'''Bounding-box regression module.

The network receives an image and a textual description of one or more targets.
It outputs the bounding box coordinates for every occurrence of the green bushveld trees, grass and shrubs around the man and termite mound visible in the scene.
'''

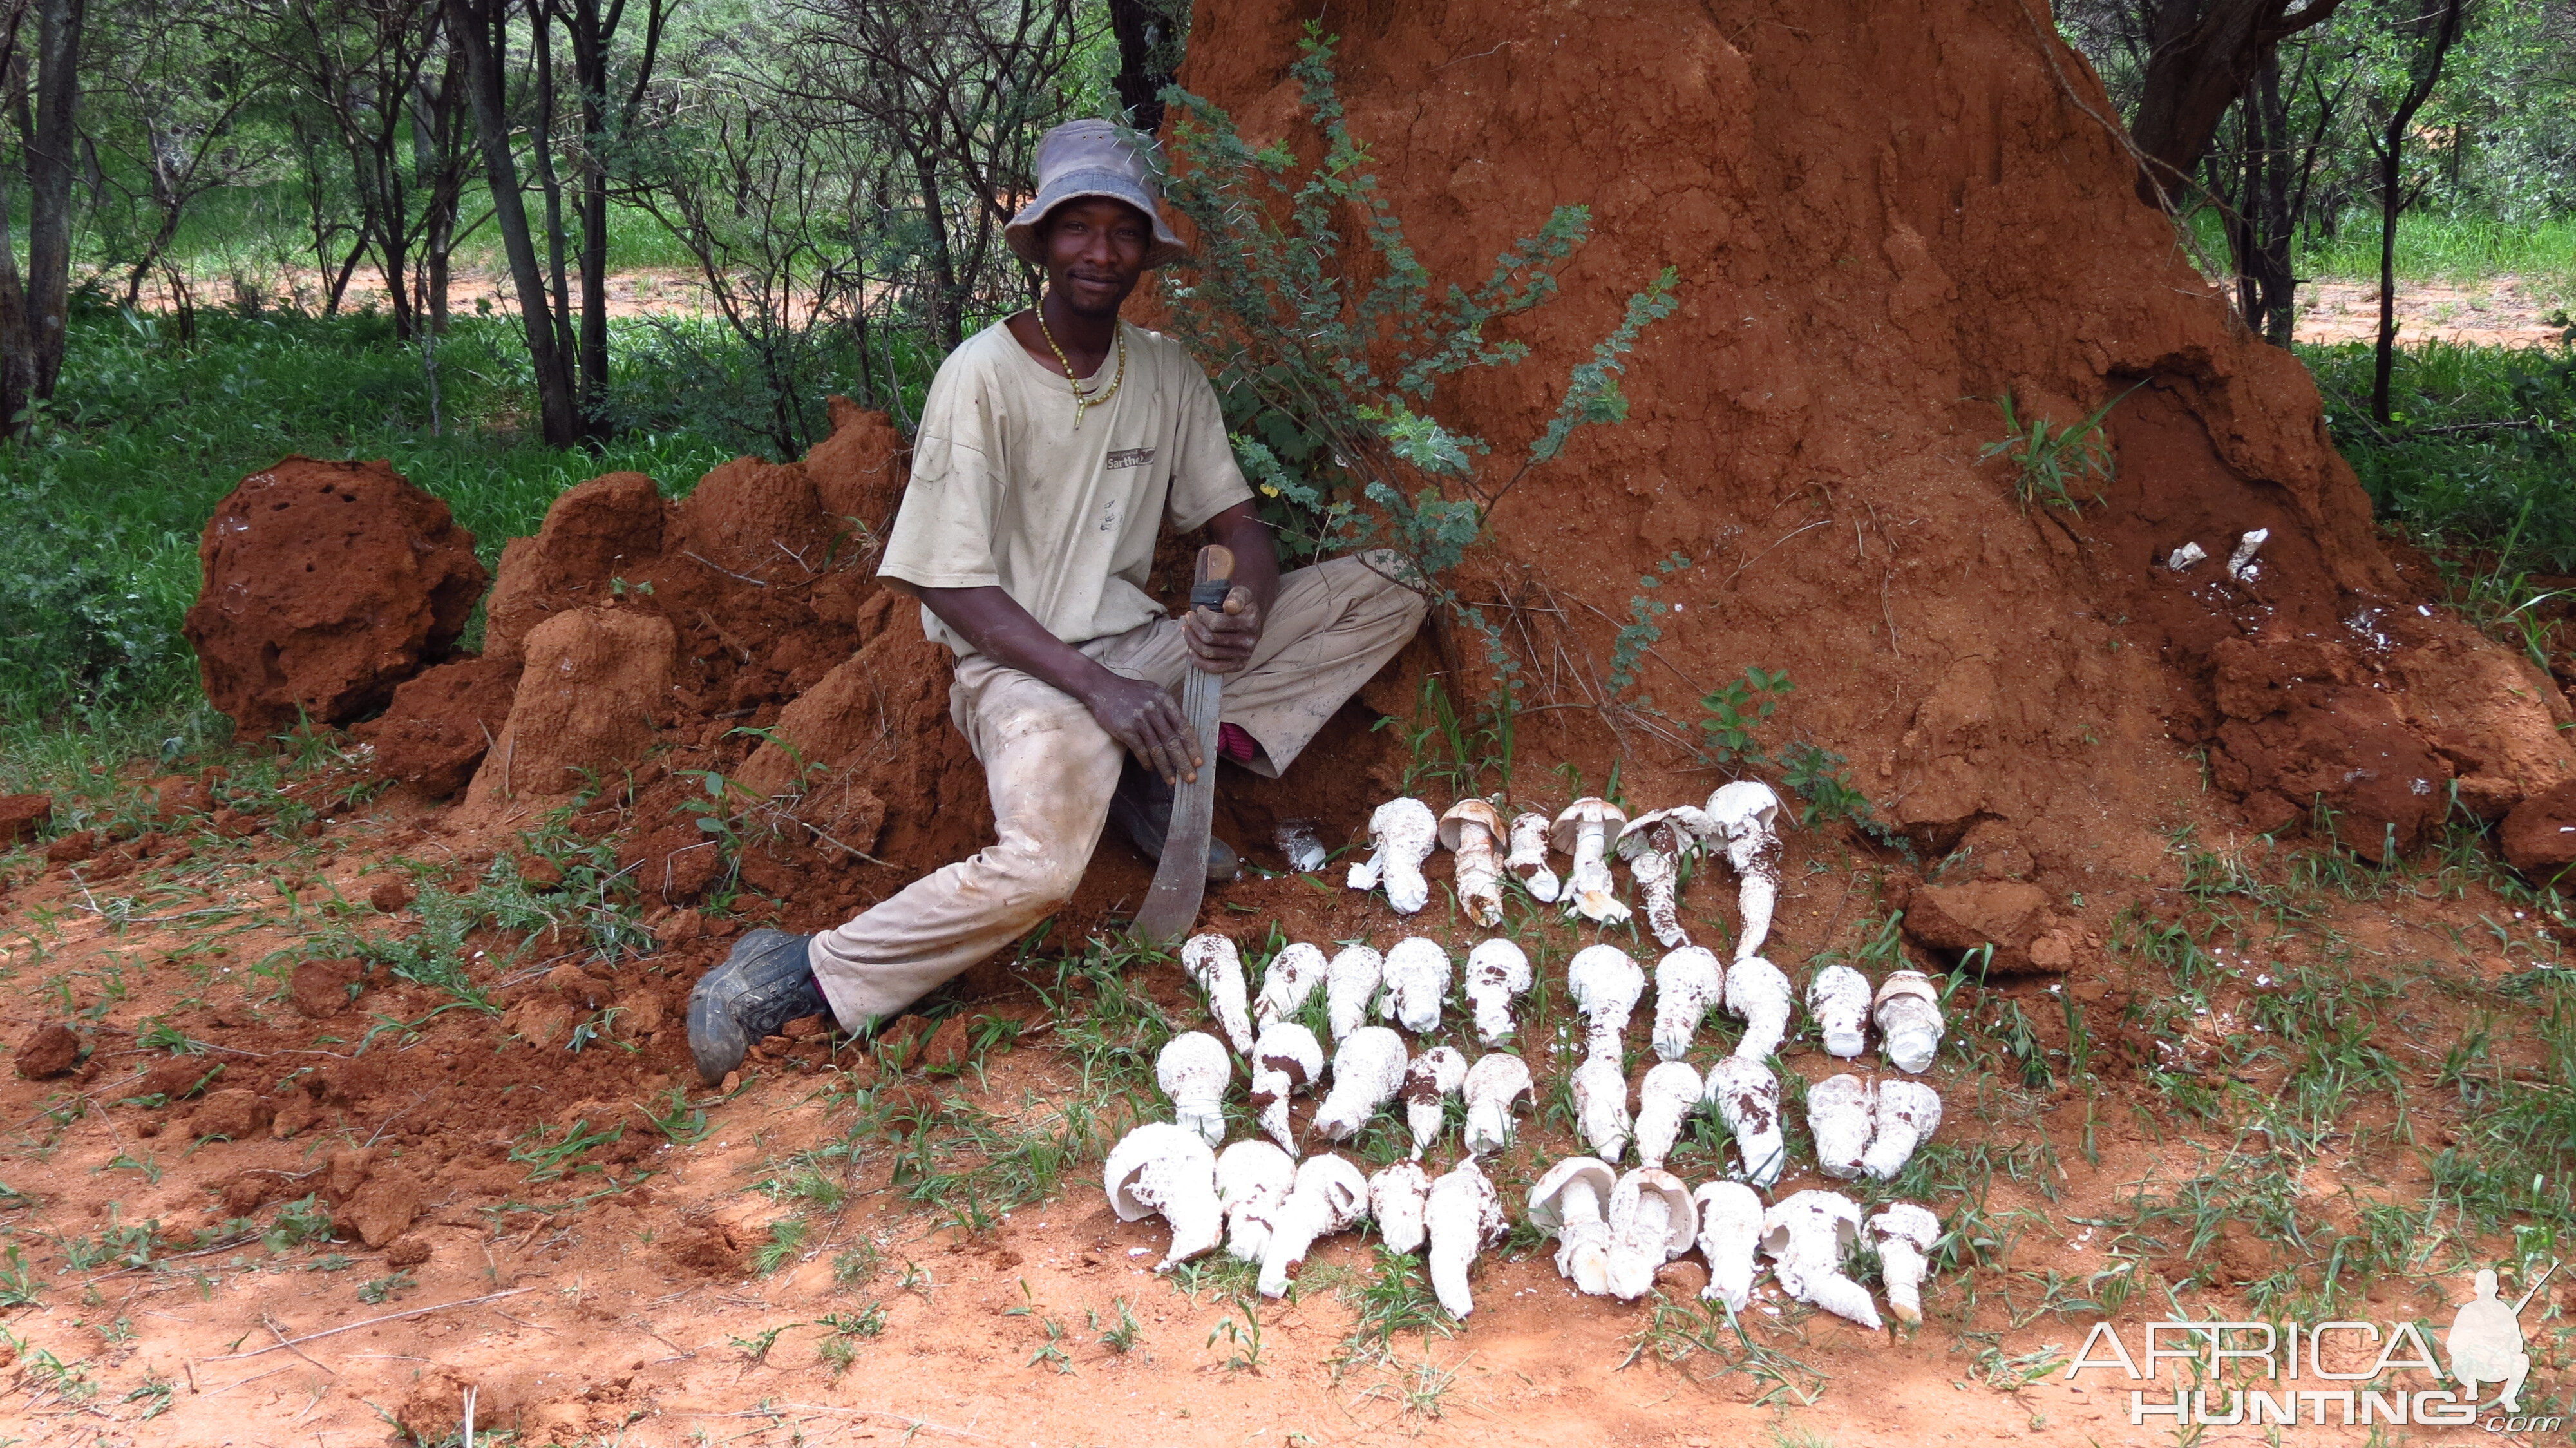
[0,0,2576,776]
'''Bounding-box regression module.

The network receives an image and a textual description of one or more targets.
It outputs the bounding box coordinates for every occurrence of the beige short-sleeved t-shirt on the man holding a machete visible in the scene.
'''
[878,322,1252,657]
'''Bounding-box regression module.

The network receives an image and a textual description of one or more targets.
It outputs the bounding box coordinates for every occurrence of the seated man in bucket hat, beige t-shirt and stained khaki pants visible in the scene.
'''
[688,121,1425,1082]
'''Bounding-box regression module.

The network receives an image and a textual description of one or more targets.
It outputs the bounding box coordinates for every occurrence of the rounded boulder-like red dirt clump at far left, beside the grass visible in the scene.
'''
[185,459,489,734]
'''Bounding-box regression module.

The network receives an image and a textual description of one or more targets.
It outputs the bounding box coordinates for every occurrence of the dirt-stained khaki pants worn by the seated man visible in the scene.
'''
[806,559,1425,1031]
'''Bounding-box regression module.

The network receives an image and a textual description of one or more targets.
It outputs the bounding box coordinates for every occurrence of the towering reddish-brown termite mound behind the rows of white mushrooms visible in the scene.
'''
[1182,0,2571,894]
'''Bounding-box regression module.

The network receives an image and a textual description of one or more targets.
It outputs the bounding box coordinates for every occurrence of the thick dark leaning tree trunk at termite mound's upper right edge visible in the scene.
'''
[2128,0,2342,211]
